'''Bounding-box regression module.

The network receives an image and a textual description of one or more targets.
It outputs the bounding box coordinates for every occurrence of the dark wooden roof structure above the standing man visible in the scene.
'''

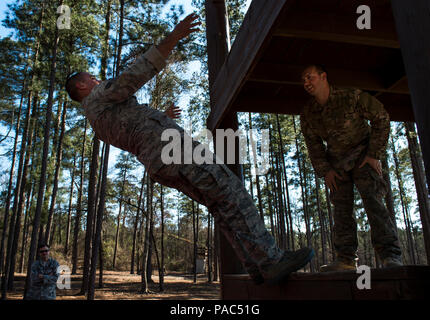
[208,0,414,130]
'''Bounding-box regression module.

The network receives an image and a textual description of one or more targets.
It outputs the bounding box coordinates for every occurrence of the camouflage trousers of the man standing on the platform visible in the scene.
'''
[330,157,401,261]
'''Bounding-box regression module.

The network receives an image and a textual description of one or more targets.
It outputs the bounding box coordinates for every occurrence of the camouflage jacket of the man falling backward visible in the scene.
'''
[82,47,167,172]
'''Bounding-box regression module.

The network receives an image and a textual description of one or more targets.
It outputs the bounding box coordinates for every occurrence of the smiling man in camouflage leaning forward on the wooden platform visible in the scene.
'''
[300,65,402,271]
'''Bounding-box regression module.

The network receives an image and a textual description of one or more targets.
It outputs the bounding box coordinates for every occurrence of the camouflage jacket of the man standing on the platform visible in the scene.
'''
[300,86,390,177]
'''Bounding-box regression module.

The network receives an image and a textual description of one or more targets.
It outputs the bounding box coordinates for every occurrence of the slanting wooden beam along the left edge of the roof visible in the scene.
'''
[207,0,295,130]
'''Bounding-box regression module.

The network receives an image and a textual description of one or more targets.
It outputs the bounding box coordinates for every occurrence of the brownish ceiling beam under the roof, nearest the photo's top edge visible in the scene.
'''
[274,6,400,48]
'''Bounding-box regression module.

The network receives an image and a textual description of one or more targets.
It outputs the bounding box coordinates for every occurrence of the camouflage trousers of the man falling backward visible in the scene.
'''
[144,112,283,278]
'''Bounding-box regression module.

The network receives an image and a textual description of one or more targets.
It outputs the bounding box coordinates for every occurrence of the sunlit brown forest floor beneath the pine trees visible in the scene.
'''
[8,271,221,300]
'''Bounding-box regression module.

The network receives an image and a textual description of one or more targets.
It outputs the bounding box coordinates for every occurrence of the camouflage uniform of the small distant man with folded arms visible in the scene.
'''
[28,258,60,300]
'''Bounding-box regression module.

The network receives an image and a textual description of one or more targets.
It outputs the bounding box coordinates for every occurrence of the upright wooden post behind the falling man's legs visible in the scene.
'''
[205,0,244,290]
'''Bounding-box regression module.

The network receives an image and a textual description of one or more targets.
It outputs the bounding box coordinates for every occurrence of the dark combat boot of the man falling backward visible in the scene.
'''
[261,248,314,285]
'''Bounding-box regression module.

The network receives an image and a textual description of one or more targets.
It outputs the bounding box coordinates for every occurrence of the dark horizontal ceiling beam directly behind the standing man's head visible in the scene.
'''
[248,63,409,94]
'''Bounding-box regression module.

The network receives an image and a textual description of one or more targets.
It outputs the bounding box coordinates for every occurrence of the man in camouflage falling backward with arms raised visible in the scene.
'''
[66,14,313,284]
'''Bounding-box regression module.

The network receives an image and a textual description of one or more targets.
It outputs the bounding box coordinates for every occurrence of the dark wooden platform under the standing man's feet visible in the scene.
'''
[222,266,430,300]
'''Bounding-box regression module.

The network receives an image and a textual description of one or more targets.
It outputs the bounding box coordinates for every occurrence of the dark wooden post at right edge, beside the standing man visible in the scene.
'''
[391,0,430,264]
